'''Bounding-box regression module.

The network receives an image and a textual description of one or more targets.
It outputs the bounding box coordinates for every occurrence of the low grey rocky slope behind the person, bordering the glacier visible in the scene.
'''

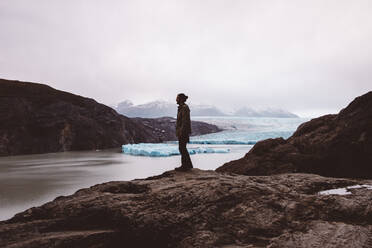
[131,117,222,142]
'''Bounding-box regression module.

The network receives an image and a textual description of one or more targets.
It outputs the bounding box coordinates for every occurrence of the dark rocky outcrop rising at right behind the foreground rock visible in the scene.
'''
[217,92,372,178]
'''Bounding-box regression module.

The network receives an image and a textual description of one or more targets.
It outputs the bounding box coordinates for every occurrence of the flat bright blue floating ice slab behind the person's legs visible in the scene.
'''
[122,143,230,157]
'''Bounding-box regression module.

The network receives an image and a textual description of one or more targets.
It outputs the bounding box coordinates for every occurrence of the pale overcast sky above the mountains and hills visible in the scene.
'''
[0,0,372,116]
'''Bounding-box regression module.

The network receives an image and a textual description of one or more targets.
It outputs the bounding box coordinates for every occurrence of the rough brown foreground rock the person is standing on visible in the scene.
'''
[0,169,372,248]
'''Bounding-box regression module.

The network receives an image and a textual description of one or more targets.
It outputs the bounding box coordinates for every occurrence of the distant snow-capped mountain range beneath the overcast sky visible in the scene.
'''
[114,100,298,118]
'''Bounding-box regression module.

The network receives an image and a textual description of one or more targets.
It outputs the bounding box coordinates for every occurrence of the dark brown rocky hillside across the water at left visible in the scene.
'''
[0,79,221,156]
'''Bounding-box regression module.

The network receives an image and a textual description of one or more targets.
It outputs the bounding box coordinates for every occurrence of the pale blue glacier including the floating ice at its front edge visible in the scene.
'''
[122,116,307,157]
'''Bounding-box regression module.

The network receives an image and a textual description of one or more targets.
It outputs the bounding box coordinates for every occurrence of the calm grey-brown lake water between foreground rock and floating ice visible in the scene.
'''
[0,145,252,220]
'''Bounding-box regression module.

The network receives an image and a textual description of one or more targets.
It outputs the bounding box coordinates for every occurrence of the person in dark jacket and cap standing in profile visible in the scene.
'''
[175,93,193,171]
